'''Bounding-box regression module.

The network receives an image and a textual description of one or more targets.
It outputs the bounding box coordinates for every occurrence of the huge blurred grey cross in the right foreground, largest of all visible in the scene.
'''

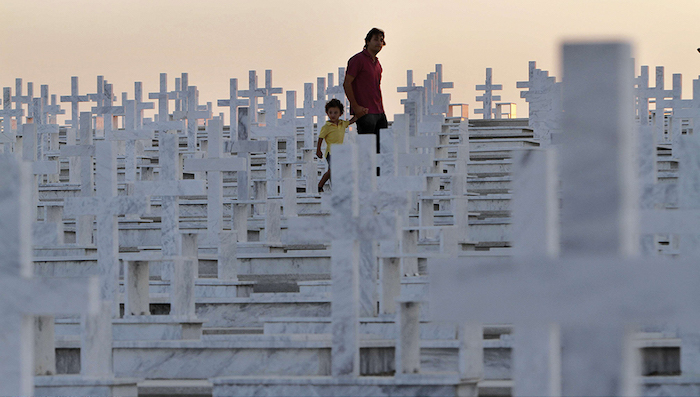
[429,43,700,396]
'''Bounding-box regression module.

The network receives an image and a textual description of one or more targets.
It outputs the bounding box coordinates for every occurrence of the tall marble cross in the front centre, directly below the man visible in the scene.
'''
[288,136,397,377]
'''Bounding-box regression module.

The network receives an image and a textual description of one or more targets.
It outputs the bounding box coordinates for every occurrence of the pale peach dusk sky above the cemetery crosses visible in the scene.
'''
[0,0,700,123]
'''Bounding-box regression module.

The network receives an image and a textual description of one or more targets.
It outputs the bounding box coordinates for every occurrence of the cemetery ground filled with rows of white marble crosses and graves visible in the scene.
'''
[0,43,700,396]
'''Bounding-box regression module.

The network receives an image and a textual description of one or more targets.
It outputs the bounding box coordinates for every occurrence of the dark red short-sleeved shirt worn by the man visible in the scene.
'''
[345,49,384,114]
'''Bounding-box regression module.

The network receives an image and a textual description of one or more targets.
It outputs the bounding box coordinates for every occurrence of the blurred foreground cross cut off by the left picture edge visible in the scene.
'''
[0,155,98,396]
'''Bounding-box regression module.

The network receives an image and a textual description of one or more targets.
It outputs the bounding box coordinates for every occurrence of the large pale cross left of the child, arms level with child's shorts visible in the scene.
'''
[185,117,248,245]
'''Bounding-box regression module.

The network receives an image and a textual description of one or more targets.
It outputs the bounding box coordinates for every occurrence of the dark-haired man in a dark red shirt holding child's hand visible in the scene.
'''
[343,28,388,153]
